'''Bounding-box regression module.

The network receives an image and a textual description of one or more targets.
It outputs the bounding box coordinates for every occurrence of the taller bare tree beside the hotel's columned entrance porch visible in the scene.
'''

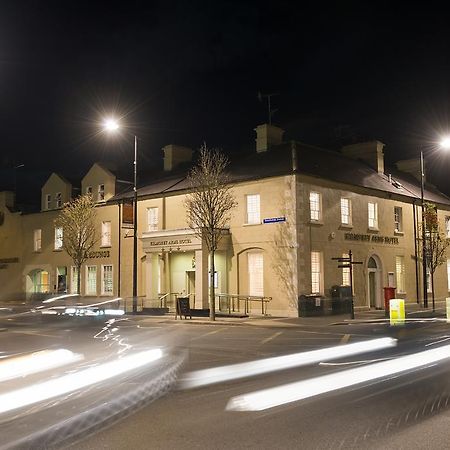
[185,144,236,320]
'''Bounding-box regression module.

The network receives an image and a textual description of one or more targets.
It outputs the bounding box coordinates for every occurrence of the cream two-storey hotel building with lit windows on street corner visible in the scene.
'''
[0,124,450,316]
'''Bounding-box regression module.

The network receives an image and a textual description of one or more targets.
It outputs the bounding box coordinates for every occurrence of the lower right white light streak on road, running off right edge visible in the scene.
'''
[226,345,450,411]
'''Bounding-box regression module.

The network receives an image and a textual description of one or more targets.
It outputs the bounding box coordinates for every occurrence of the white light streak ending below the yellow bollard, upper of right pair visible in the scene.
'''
[181,337,397,389]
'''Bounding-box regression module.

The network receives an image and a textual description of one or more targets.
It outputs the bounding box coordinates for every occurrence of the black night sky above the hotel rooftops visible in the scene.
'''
[0,0,450,202]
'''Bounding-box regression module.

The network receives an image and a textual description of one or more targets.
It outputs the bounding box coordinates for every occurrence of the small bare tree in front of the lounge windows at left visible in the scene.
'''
[55,194,98,293]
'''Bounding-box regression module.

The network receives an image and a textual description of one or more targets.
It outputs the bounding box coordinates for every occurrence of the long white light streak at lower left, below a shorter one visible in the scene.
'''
[0,349,163,413]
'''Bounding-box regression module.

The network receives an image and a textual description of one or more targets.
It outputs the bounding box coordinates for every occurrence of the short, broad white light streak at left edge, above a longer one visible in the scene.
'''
[0,349,83,381]
